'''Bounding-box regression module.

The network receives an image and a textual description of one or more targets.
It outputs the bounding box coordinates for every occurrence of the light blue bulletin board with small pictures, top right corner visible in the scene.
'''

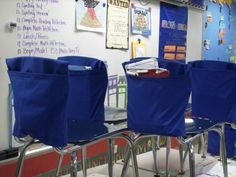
[203,1,236,62]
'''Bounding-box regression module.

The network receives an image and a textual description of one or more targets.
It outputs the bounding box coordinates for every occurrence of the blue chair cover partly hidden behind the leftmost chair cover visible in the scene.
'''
[58,56,108,126]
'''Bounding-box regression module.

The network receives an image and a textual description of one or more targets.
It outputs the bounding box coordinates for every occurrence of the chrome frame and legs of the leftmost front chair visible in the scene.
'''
[16,129,139,177]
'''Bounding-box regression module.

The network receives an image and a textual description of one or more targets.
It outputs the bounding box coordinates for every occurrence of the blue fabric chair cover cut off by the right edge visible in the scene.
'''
[190,60,236,123]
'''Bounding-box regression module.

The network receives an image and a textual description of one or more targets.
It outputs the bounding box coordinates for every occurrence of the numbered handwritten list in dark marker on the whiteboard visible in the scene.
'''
[16,0,79,56]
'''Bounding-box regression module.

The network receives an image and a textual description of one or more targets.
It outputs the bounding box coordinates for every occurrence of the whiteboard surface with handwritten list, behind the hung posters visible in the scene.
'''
[0,0,202,151]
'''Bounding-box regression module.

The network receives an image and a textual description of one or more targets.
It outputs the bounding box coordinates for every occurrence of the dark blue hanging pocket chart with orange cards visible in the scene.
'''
[159,2,188,61]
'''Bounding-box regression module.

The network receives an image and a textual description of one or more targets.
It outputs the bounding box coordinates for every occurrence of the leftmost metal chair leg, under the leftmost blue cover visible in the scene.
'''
[15,140,34,177]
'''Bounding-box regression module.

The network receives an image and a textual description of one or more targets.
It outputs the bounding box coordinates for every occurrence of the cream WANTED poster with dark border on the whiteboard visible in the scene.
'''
[106,0,130,49]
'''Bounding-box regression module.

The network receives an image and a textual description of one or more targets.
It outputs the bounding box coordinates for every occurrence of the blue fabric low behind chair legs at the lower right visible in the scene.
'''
[207,126,236,158]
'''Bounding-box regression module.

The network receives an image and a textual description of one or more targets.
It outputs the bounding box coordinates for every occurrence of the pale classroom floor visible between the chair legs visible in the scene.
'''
[64,148,236,177]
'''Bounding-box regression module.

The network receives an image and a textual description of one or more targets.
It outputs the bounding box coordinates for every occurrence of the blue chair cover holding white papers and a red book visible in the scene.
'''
[123,58,190,136]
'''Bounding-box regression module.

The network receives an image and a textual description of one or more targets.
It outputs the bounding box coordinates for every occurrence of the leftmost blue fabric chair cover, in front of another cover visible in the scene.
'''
[6,57,68,147]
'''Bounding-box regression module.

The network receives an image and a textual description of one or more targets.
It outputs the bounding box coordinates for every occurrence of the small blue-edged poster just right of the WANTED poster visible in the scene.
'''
[131,4,151,36]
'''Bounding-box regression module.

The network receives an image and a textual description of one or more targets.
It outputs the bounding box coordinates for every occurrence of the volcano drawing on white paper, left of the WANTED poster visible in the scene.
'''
[76,0,107,32]
